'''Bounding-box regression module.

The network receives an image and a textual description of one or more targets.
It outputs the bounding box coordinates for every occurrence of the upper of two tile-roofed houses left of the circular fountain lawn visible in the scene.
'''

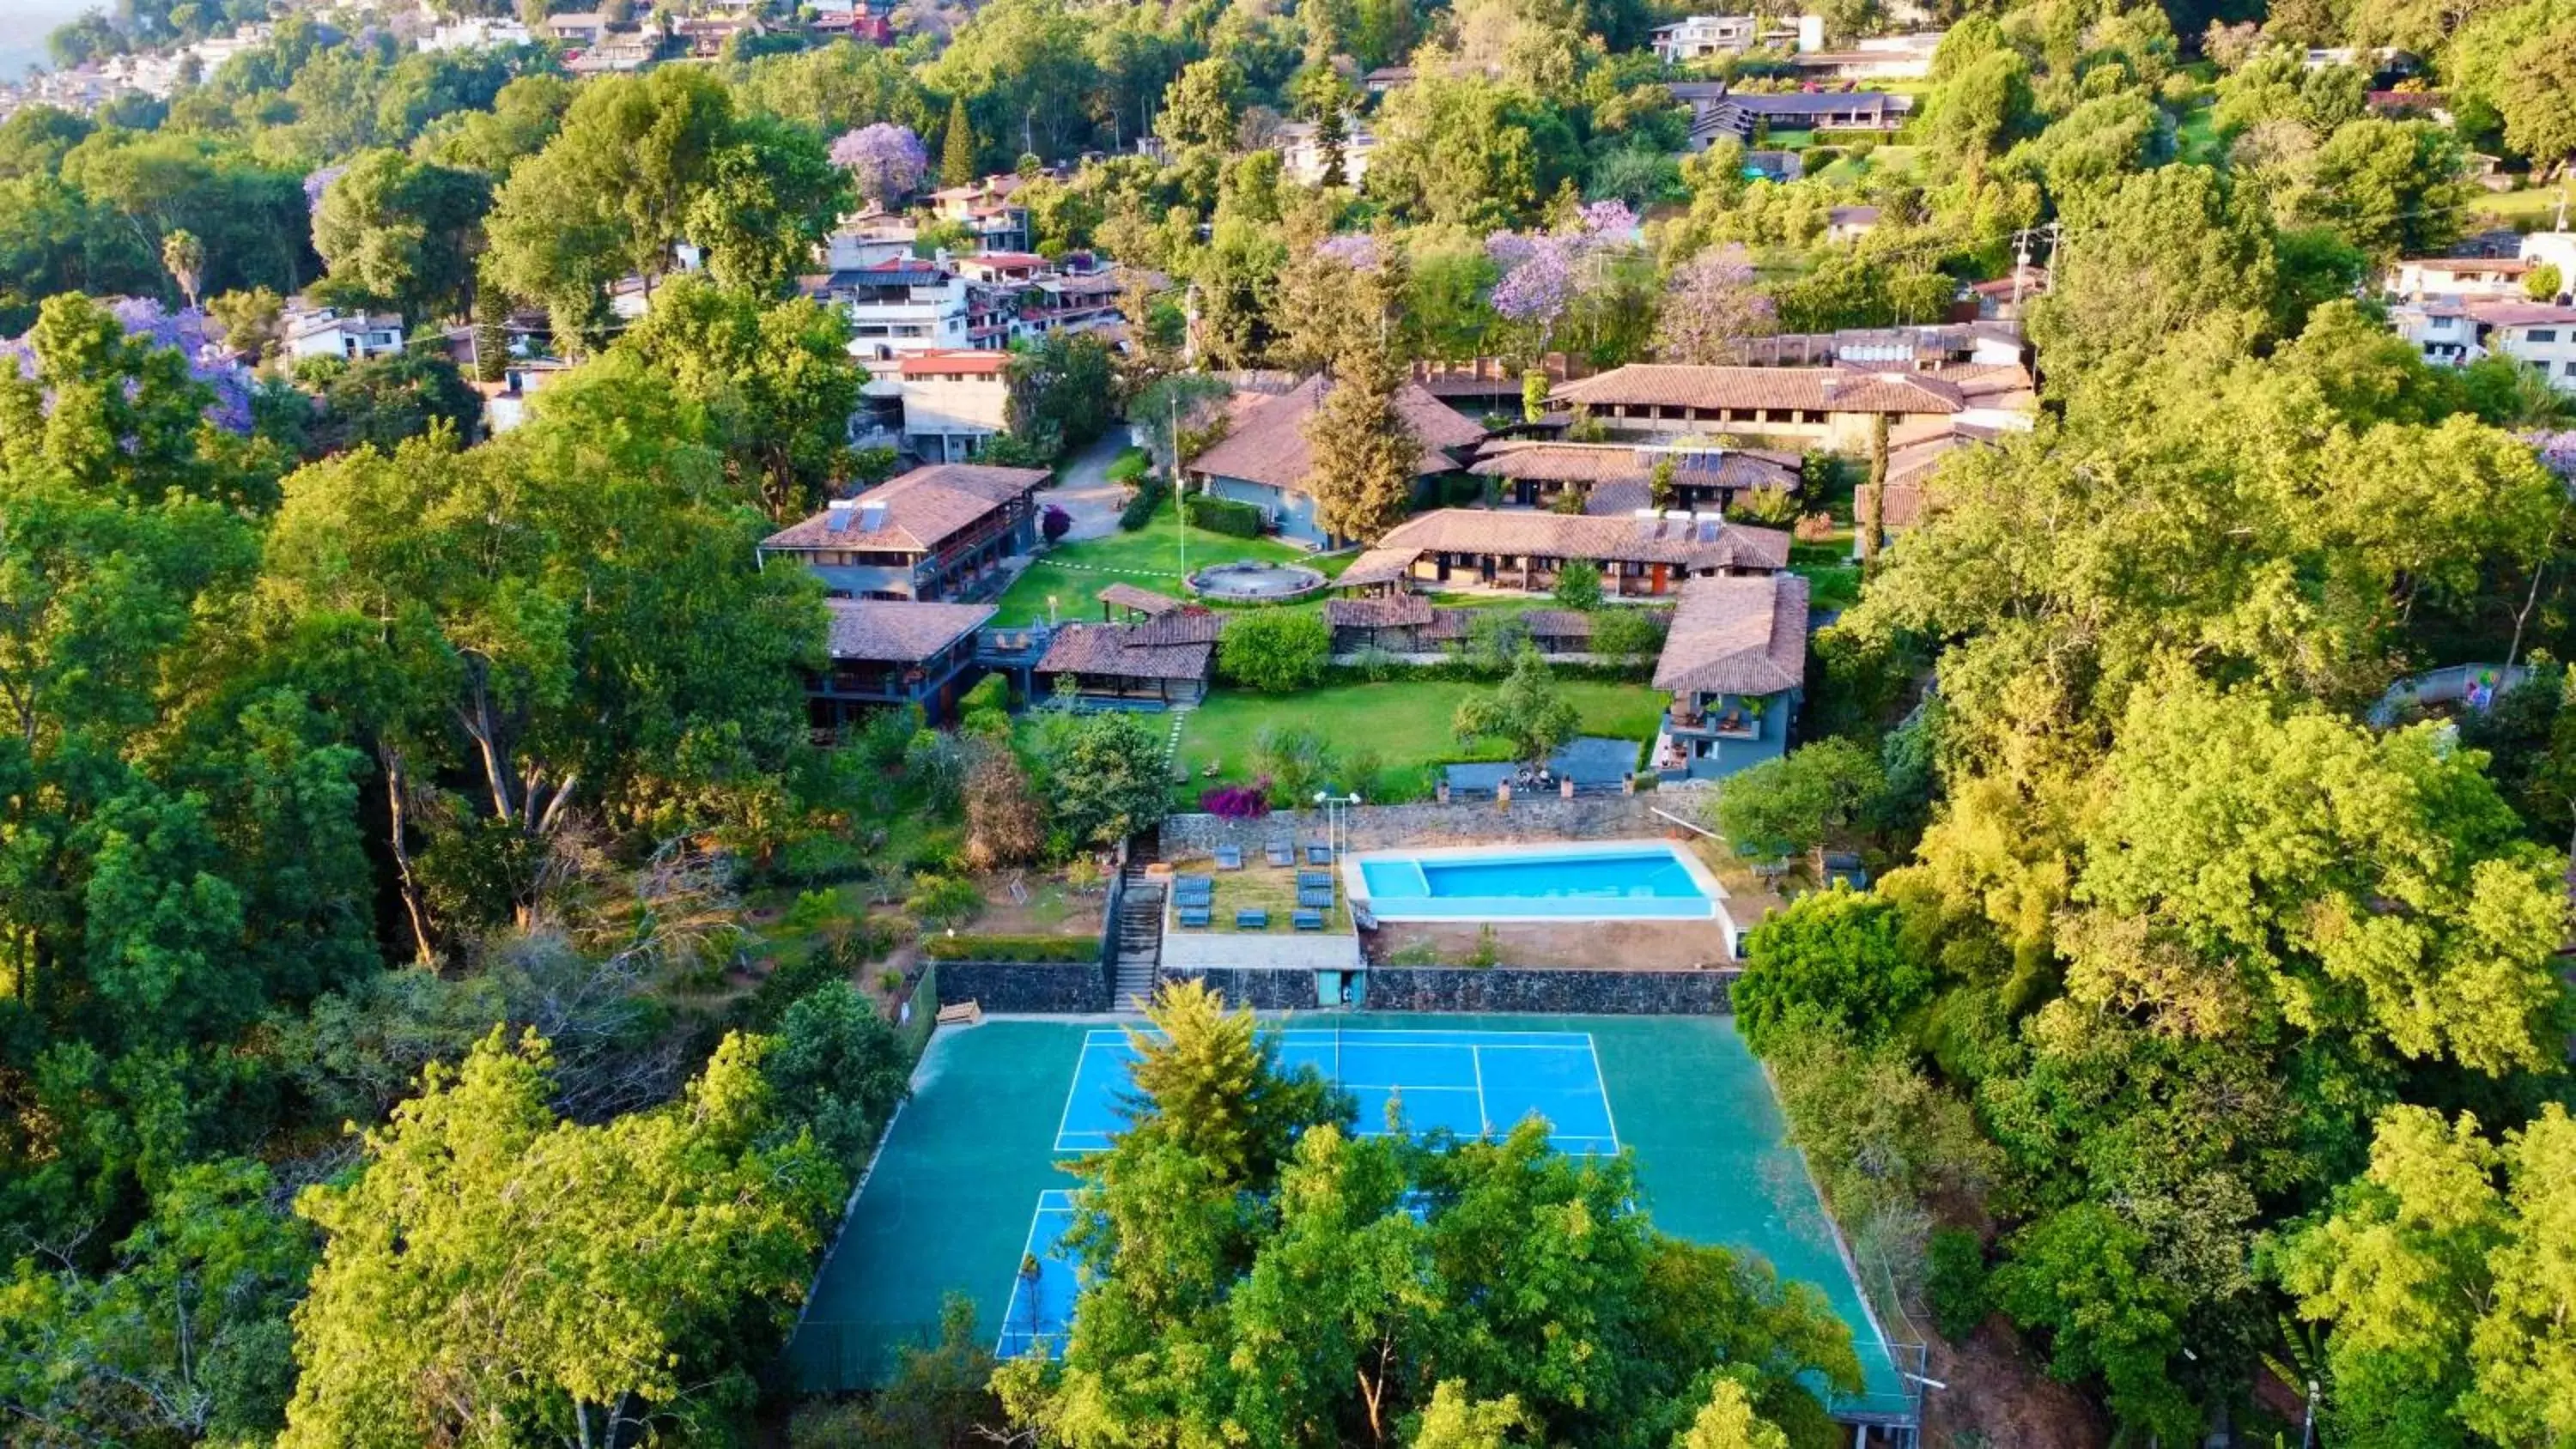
[760,464,1046,600]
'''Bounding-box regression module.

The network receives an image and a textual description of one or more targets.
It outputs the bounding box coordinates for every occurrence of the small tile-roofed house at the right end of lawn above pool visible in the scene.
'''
[1651,574,1806,779]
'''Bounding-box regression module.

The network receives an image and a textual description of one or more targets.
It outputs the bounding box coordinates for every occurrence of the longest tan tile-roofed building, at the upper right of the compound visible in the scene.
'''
[1548,363,2030,453]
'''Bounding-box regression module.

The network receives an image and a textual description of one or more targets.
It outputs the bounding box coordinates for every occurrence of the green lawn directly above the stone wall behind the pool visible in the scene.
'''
[1180,680,1667,800]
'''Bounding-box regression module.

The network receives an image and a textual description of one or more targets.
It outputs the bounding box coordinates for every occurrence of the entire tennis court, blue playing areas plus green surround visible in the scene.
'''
[788,1014,1909,1413]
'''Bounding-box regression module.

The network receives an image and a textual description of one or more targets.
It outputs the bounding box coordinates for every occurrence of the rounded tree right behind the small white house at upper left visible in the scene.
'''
[314,149,492,327]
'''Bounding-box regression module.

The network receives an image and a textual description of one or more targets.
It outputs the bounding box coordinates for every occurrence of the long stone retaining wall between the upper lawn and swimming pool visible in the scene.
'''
[1162,792,1692,859]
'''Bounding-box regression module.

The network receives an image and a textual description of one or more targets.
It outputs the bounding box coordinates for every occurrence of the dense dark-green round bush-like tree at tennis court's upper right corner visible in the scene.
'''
[1734,890,1932,1055]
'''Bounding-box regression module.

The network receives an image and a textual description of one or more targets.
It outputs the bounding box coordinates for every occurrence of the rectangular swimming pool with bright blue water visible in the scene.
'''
[1342,839,1726,921]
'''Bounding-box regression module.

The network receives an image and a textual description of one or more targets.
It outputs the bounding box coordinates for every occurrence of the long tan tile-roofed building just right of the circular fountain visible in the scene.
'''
[1337,507,1790,600]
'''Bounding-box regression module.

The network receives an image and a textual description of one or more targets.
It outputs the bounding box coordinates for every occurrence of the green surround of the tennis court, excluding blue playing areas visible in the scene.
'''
[788,1014,1911,1418]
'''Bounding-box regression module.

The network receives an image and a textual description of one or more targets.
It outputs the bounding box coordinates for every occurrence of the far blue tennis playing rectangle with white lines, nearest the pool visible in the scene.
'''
[1056,1029,1618,1155]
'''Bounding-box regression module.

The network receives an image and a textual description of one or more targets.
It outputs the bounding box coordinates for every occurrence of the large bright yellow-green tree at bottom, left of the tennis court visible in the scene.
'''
[278,1029,845,1446]
